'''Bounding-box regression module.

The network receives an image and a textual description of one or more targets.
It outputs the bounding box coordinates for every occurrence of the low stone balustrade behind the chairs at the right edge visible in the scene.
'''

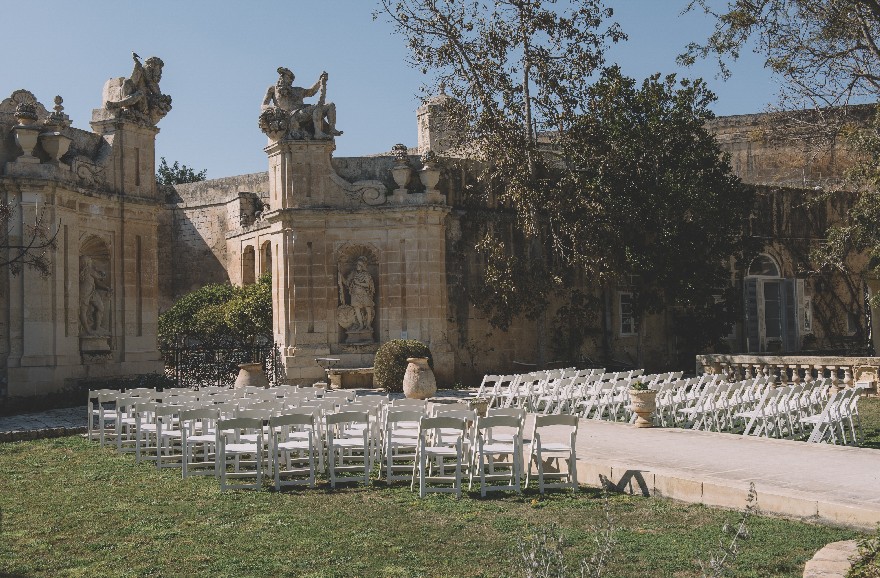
[697,354,880,391]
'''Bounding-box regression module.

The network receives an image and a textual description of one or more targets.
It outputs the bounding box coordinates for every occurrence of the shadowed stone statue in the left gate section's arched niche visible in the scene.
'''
[79,237,111,337]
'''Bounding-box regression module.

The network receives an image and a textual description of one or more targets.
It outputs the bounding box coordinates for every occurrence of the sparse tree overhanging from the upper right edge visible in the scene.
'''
[681,0,880,305]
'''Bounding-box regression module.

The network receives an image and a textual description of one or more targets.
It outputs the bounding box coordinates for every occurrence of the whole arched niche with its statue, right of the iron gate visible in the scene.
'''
[336,245,378,344]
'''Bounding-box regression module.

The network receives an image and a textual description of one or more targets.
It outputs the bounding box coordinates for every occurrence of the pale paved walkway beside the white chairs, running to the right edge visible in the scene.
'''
[0,407,880,530]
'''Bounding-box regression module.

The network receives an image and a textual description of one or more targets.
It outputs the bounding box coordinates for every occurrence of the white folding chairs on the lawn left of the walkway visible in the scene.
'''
[87,394,577,495]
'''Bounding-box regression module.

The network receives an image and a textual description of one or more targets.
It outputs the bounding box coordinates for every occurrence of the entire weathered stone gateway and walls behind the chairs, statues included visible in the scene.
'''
[0,58,878,395]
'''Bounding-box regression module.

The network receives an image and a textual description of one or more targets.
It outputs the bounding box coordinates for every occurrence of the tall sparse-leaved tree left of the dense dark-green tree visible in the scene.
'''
[376,0,625,360]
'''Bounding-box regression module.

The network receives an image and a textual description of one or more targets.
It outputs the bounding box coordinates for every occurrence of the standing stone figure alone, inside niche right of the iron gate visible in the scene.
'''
[337,255,376,343]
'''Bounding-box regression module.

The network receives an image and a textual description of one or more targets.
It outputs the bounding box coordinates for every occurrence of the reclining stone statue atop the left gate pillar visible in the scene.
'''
[104,52,171,126]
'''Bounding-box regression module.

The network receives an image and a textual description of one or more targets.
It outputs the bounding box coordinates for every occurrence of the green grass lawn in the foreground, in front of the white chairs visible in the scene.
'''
[0,436,859,578]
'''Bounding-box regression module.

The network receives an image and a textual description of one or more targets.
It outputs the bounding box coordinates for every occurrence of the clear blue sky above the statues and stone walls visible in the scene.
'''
[0,0,776,178]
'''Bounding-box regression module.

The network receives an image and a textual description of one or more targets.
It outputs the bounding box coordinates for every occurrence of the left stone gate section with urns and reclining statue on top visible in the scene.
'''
[0,58,170,396]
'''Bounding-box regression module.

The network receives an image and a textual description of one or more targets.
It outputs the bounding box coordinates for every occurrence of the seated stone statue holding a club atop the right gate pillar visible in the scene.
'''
[259,66,342,140]
